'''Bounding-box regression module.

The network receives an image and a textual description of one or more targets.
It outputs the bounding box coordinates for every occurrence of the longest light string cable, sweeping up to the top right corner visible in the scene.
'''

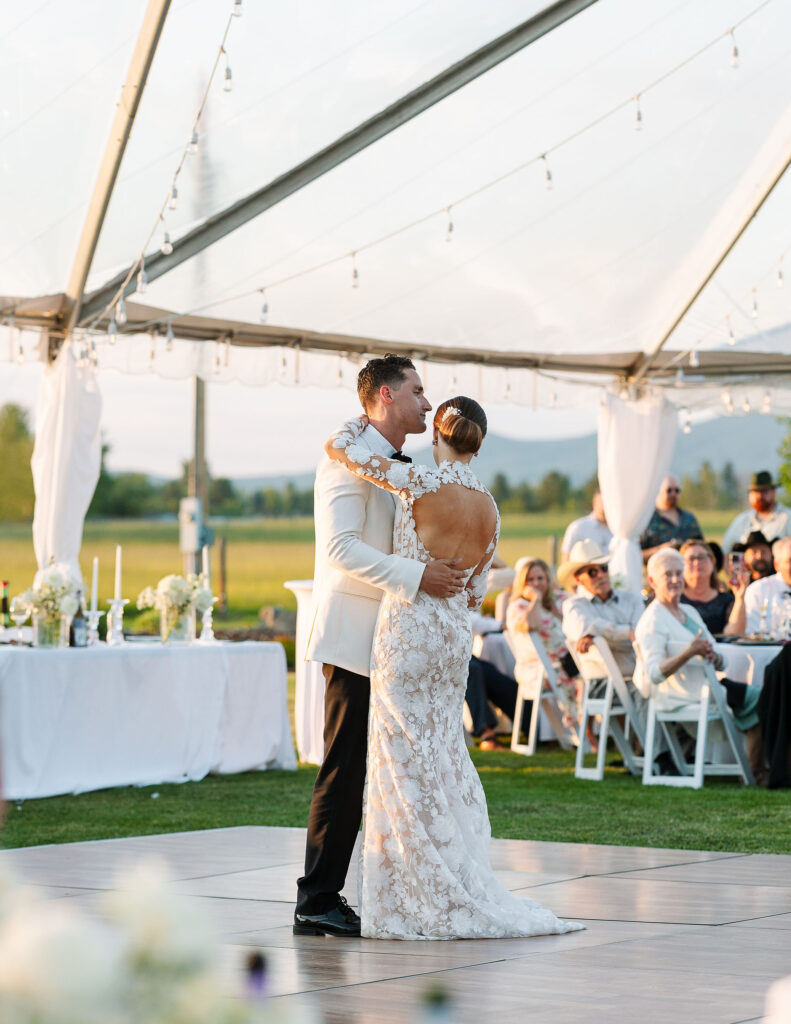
[123,0,773,330]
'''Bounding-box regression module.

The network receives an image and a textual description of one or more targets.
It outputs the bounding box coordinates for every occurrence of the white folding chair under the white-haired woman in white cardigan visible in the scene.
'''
[642,664,755,790]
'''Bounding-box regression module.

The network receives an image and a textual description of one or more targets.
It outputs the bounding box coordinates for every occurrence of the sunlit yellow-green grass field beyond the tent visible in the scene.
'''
[0,512,733,627]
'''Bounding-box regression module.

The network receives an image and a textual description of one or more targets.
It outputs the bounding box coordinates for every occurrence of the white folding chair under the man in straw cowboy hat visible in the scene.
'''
[570,637,646,782]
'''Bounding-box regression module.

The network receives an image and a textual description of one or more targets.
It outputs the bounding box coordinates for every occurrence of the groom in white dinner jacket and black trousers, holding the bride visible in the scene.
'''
[294,354,464,936]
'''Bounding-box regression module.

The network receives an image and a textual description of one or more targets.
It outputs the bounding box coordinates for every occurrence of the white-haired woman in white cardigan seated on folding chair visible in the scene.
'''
[634,548,762,772]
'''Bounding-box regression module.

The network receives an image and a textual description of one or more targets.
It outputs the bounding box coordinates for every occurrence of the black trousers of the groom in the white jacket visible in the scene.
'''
[296,665,371,913]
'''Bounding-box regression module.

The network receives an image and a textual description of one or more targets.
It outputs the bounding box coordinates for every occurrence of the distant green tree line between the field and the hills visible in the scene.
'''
[0,403,778,522]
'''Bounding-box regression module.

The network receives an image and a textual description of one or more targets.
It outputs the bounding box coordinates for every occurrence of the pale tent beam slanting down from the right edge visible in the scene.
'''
[627,106,791,384]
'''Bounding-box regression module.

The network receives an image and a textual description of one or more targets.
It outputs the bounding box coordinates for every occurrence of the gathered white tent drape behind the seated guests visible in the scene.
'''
[598,394,678,591]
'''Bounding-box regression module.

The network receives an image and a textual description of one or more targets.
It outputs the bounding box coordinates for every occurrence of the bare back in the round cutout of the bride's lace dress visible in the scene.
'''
[412,483,497,569]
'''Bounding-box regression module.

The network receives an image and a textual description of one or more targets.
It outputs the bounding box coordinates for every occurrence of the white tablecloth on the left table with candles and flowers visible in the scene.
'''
[0,642,296,800]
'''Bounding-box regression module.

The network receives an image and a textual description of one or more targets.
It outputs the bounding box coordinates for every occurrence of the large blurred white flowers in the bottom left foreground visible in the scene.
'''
[0,861,304,1024]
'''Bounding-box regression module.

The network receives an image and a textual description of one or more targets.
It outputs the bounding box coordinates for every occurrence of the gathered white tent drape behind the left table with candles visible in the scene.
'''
[31,343,101,580]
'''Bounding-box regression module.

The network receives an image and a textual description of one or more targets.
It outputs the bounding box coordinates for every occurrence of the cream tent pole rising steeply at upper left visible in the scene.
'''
[65,0,170,335]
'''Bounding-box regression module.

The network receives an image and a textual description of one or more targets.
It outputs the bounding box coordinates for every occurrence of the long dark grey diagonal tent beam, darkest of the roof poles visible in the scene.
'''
[81,0,597,322]
